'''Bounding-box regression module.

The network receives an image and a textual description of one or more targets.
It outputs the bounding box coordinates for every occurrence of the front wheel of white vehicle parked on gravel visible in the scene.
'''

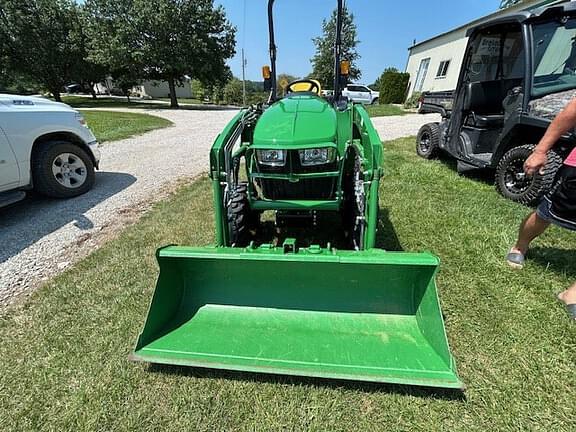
[32,141,95,198]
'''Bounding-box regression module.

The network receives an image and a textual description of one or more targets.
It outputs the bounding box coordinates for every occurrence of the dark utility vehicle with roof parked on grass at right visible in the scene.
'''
[416,2,576,205]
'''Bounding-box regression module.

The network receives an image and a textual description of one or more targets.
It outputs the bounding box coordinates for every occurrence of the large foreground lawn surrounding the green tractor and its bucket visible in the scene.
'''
[0,139,576,432]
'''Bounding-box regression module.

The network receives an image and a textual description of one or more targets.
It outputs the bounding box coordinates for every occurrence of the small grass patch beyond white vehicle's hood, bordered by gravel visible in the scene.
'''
[82,110,172,143]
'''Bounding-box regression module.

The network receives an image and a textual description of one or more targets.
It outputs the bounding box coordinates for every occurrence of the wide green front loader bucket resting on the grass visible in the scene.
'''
[133,246,463,389]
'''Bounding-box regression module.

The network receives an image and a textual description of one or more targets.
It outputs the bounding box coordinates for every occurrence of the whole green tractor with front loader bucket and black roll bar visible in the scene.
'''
[133,0,463,389]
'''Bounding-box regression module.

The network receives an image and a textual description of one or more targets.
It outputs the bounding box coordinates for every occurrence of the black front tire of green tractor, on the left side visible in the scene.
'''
[227,183,260,247]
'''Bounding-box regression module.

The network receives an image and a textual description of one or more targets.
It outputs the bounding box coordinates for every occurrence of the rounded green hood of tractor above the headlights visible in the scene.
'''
[253,95,337,149]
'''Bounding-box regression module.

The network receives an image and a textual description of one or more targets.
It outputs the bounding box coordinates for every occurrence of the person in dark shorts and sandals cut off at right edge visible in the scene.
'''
[506,99,576,320]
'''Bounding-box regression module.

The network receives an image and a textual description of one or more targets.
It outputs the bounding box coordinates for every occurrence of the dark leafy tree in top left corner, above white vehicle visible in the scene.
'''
[0,0,84,101]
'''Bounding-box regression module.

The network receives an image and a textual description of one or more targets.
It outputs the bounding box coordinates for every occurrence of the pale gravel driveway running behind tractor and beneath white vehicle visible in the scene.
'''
[0,109,438,307]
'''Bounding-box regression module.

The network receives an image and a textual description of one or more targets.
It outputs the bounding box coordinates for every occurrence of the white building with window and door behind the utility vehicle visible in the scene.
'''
[406,0,566,96]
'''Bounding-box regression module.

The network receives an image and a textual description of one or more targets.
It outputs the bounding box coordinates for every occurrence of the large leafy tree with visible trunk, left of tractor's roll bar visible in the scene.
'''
[86,0,236,108]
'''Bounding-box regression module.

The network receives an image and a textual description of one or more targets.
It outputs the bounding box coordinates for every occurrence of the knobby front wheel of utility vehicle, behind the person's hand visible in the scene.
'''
[496,144,562,206]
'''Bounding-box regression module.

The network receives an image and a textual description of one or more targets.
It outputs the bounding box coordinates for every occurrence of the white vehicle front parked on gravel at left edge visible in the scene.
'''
[0,94,100,207]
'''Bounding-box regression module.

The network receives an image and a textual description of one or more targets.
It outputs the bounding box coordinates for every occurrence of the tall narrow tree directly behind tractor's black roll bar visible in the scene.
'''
[310,7,362,88]
